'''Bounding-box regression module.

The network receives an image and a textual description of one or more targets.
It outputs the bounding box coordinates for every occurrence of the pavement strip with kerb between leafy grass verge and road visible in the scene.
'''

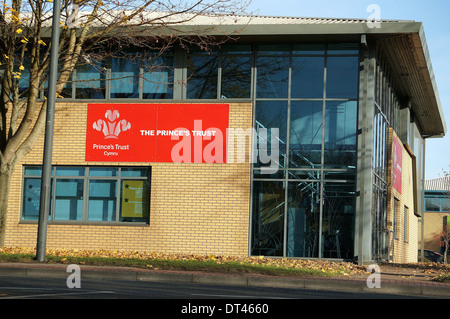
[0,263,450,298]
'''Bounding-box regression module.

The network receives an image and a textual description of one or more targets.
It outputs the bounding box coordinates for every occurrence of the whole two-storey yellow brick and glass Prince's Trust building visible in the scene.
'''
[5,17,446,263]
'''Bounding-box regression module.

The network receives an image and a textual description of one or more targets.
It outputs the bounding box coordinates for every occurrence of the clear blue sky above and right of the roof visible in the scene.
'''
[249,0,450,179]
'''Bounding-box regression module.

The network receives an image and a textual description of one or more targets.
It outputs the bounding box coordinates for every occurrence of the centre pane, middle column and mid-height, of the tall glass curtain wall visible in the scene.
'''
[289,101,323,168]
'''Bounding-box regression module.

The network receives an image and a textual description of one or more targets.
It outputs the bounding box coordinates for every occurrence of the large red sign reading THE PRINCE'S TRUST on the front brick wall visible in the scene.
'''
[86,103,229,163]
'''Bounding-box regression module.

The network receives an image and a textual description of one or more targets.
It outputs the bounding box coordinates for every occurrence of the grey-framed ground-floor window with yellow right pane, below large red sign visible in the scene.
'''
[22,166,150,223]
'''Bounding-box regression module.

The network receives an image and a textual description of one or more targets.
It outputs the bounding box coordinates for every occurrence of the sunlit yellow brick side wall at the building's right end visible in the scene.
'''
[387,128,418,263]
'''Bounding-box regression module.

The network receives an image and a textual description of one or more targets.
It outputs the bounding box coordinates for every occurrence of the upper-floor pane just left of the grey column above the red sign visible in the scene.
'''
[143,57,174,99]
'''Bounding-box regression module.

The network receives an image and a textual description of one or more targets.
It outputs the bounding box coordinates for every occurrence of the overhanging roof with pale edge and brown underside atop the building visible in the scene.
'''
[38,12,447,137]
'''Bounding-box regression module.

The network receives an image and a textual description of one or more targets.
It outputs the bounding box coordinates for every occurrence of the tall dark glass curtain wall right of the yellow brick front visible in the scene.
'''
[250,44,359,259]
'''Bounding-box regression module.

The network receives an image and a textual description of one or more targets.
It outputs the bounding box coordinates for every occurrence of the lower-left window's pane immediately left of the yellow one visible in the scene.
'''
[88,180,117,221]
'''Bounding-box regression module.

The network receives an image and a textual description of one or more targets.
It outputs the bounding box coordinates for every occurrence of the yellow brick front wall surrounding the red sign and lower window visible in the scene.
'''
[5,102,252,255]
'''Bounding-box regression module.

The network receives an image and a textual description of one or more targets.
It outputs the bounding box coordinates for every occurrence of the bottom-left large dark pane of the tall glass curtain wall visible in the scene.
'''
[251,181,285,256]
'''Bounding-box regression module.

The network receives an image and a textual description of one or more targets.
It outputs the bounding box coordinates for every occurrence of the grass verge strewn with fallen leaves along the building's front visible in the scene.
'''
[0,252,360,277]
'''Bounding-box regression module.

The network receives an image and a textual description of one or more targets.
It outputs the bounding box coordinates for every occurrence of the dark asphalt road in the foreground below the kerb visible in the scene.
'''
[0,276,428,301]
